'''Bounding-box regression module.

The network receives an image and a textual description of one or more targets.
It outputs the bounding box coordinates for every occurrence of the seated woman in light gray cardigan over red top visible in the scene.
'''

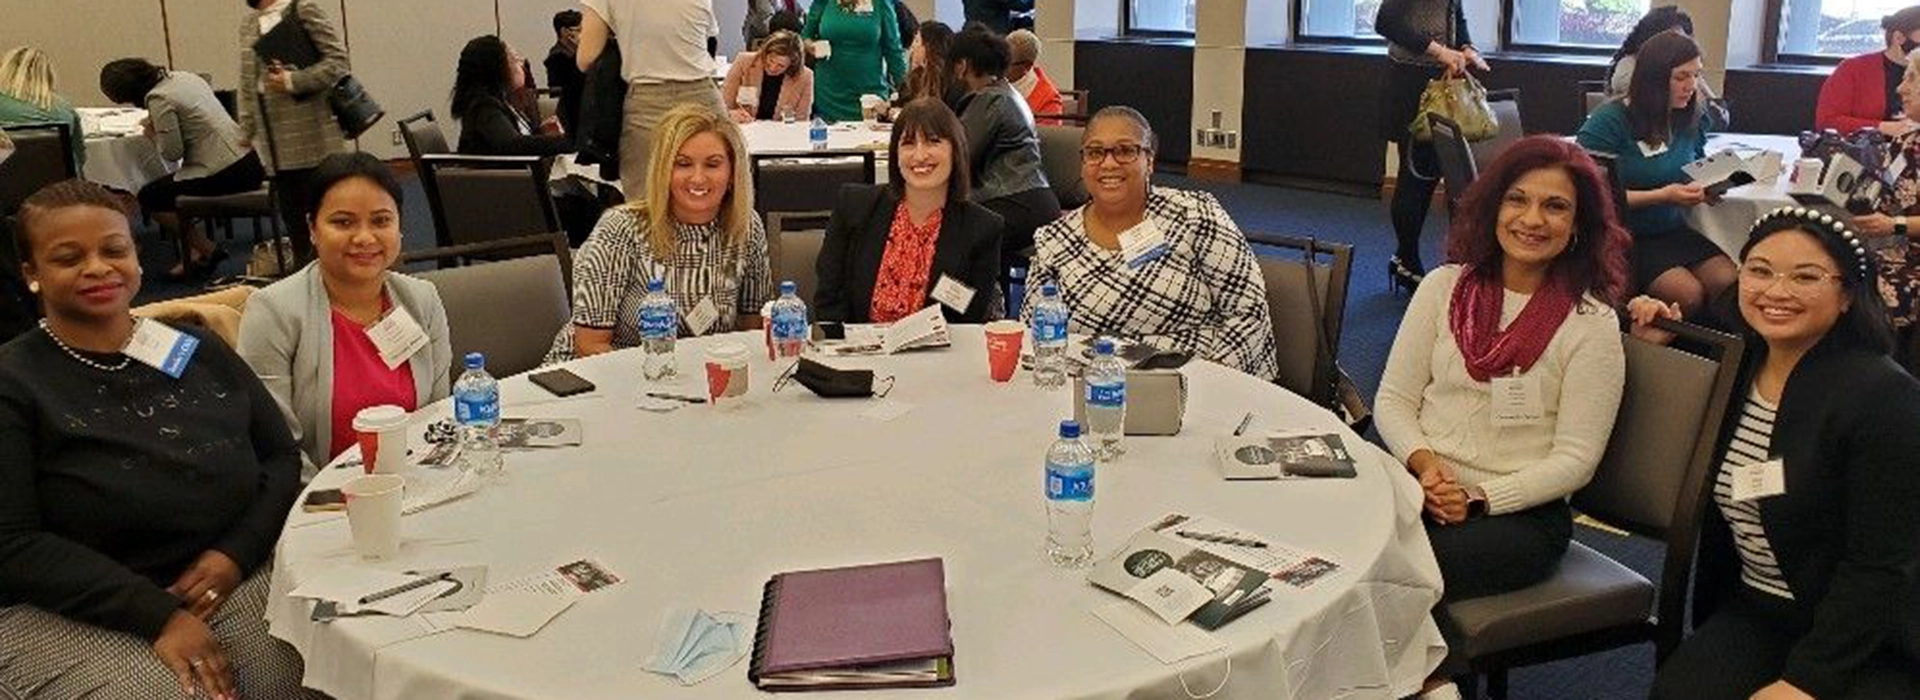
[240,153,453,478]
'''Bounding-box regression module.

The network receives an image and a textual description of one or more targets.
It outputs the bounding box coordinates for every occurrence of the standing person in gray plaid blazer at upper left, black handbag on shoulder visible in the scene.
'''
[238,0,349,265]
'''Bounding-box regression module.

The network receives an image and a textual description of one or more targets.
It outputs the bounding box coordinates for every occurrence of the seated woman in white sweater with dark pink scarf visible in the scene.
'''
[1377,136,1628,698]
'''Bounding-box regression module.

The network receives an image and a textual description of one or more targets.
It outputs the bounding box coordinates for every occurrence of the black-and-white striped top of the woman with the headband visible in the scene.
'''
[1713,391,1793,600]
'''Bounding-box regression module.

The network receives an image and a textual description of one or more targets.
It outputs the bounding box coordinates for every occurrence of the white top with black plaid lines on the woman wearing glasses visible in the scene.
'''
[1021,188,1279,380]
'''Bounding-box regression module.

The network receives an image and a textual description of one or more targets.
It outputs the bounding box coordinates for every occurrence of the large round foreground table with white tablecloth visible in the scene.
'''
[267,326,1444,700]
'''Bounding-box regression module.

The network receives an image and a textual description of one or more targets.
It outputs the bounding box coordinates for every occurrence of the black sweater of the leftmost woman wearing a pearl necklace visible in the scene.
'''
[0,328,300,639]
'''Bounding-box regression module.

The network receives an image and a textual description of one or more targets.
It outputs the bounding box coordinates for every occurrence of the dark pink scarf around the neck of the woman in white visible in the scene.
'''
[1448,267,1574,382]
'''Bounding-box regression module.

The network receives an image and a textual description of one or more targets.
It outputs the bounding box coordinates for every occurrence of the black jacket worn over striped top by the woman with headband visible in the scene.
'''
[1695,337,1920,698]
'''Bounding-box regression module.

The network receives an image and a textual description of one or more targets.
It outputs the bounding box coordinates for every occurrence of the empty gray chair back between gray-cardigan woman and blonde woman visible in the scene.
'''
[396,232,572,376]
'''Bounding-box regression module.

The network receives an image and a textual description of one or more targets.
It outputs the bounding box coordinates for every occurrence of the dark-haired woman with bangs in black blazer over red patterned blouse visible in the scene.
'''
[814,98,1002,324]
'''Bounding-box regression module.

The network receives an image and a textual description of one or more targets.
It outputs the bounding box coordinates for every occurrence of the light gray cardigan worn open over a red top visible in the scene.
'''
[240,263,453,478]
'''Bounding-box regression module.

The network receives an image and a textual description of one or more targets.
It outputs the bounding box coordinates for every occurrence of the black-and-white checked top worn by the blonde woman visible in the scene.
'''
[547,207,774,364]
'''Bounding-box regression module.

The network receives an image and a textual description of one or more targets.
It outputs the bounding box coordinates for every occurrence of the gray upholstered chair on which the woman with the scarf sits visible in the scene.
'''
[1448,320,1743,700]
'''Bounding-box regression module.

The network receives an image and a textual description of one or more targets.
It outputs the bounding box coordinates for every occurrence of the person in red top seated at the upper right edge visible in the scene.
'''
[1812,6,1920,136]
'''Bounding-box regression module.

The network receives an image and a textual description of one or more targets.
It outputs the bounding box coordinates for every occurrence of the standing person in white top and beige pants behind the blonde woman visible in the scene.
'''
[574,0,726,199]
